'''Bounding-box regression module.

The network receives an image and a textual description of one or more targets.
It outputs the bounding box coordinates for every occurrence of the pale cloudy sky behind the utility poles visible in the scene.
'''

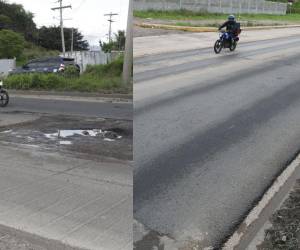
[7,0,129,45]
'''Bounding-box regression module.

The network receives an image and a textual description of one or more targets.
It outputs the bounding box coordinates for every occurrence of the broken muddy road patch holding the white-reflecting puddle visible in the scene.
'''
[0,113,132,160]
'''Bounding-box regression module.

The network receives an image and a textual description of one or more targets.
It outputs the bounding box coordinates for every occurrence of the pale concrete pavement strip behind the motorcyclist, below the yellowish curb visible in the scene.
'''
[133,28,300,57]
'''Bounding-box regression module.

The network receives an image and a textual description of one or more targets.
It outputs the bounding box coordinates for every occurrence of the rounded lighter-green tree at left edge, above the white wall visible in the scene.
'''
[0,30,25,59]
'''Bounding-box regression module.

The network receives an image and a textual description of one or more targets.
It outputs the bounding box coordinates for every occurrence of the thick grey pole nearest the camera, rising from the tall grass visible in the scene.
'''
[123,0,133,84]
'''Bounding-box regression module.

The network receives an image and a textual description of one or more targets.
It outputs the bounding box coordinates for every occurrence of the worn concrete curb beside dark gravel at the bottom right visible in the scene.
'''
[222,154,300,250]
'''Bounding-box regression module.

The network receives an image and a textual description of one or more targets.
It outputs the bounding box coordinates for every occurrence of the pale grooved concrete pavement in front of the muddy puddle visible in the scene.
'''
[0,145,132,250]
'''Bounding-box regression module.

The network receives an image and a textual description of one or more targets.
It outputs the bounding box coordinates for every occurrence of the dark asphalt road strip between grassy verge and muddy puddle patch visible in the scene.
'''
[3,97,132,120]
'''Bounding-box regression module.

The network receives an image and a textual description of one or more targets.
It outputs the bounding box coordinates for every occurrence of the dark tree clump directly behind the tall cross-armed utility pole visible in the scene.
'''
[38,26,89,51]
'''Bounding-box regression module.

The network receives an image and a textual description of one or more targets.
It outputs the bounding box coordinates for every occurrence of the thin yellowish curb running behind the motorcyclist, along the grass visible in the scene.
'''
[135,23,300,32]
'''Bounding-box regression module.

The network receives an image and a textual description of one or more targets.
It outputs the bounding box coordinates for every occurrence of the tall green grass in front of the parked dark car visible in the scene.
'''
[4,58,132,94]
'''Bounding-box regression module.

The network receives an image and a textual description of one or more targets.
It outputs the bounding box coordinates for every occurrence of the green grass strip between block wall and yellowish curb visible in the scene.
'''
[134,9,300,23]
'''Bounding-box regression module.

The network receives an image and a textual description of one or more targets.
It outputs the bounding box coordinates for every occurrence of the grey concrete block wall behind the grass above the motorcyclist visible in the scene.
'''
[133,0,287,15]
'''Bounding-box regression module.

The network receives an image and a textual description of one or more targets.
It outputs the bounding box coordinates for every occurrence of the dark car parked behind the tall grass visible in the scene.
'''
[10,56,80,75]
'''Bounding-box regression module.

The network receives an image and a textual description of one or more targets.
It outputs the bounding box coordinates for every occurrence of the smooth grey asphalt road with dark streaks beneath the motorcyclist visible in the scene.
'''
[134,32,300,247]
